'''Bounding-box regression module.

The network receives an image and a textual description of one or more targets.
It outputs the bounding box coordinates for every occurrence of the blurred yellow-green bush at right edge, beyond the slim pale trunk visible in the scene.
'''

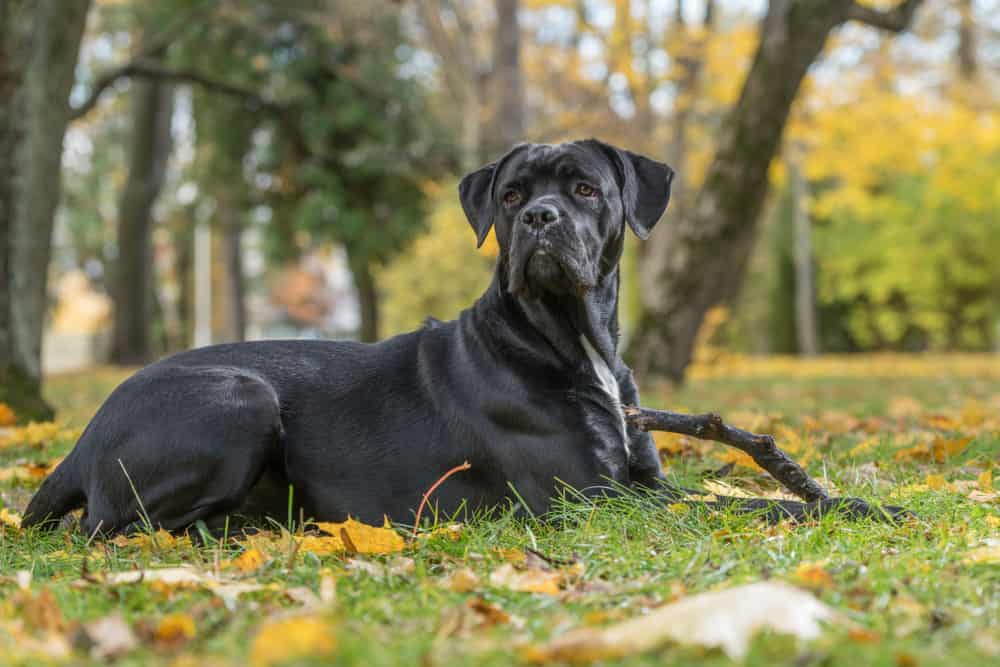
[814,98,1000,350]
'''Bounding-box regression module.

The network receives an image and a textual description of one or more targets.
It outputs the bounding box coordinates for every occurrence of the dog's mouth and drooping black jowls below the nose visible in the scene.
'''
[507,239,596,298]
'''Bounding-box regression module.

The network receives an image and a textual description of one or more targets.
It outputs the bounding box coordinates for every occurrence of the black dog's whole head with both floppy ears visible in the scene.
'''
[459,139,673,298]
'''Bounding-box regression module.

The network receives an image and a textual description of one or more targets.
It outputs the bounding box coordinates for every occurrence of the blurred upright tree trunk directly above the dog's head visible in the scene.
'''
[492,0,524,155]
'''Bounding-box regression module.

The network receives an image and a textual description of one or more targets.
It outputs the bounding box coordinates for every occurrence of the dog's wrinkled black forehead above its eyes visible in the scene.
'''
[497,143,616,189]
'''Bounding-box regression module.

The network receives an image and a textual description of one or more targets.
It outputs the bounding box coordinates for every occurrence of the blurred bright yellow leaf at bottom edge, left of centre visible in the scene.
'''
[250,616,337,667]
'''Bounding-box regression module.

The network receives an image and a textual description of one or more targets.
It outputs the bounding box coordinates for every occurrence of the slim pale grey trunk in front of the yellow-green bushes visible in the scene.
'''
[787,147,819,357]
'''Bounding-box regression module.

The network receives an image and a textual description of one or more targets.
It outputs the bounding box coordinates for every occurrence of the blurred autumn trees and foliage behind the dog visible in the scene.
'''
[0,0,1000,419]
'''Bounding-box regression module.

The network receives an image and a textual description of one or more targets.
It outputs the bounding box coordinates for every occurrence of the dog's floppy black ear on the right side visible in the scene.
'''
[590,139,674,241]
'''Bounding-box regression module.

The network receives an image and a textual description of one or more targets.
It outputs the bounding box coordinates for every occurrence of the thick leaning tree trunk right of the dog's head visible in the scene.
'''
[628,0,919,382]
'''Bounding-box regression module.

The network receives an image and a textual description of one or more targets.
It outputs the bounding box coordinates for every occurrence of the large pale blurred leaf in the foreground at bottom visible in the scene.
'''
[525,581,838,663]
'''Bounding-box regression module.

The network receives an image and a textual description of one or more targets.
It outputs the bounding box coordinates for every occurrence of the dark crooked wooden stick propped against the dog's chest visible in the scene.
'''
[624,406,829,503]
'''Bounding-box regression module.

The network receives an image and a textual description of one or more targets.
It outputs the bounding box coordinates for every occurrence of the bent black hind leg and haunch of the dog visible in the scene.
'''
[77,367,283,534]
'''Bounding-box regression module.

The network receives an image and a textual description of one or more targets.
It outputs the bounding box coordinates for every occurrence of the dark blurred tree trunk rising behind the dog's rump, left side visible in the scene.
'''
[111,49,174,365]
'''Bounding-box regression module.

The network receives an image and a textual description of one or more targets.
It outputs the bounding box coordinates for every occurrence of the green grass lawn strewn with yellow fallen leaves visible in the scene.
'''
[0,356,1000,667]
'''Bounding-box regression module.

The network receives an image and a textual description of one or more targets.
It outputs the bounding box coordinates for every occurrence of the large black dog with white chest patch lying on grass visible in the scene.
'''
[24,140,900,534]
